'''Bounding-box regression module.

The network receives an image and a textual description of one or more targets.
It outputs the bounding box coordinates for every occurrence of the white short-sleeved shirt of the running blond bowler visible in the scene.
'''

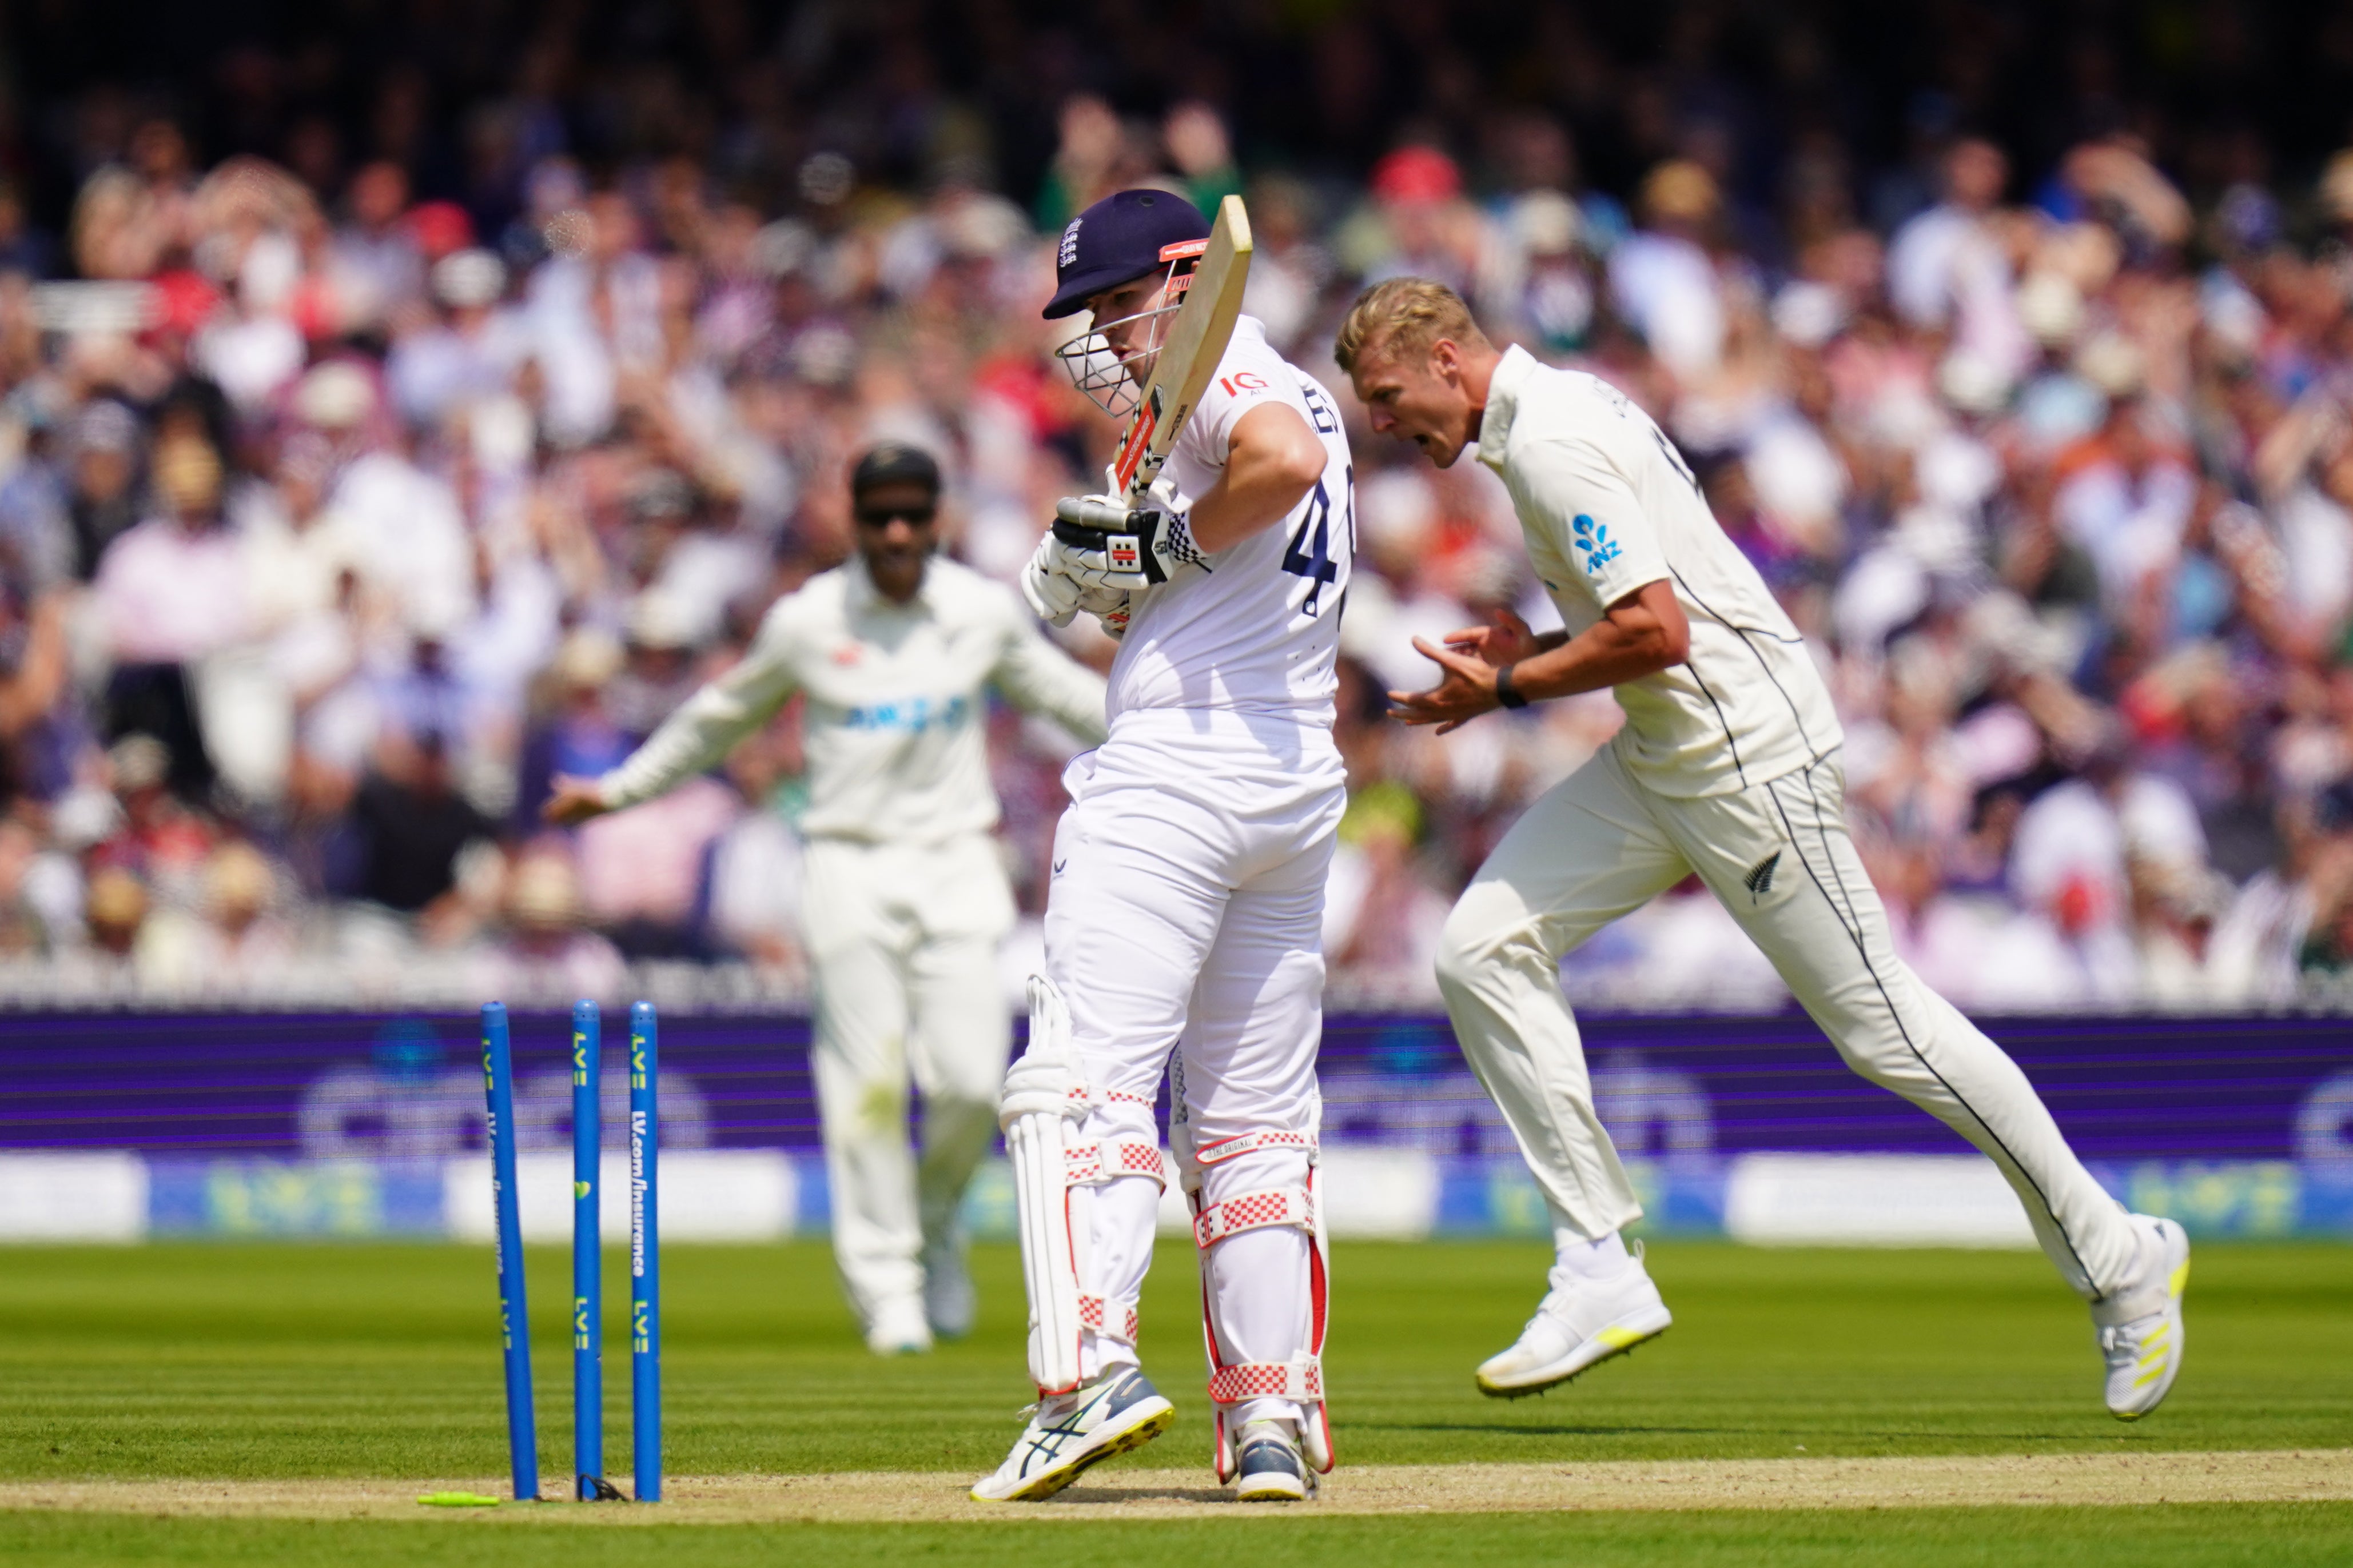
[1478,348,1842,795]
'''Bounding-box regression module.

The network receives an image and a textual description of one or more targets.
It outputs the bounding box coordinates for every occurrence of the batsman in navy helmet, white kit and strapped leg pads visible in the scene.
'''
[972,190,1353,1502]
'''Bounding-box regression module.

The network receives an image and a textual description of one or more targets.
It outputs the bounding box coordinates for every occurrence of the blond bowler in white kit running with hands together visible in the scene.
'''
[1336,277,2188,1420]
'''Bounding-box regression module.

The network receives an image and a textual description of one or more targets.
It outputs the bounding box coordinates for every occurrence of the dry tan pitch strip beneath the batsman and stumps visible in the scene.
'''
[0,1448,2353,1523]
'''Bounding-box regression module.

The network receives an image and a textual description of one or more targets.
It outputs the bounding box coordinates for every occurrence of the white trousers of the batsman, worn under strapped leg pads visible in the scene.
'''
[1045,710,1348,1429]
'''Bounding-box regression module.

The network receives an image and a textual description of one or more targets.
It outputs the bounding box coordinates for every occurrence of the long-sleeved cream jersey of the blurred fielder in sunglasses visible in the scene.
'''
[588,557,1106,841]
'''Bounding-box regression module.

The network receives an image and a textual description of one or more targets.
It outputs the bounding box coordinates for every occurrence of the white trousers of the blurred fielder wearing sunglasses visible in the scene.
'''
[802,832,1014,1326]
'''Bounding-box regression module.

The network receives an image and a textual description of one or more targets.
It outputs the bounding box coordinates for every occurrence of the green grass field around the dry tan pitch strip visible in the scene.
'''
[0,1241,2353,1563]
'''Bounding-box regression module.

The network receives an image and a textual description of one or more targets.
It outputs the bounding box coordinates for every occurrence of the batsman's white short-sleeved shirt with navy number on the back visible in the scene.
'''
[1110,315,1355,727]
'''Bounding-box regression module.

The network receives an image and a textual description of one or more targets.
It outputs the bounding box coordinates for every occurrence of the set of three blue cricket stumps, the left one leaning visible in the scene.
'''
[483,1002,661,1502]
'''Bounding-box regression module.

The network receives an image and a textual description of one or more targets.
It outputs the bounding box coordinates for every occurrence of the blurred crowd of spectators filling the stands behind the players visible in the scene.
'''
[0,7,2353,1008]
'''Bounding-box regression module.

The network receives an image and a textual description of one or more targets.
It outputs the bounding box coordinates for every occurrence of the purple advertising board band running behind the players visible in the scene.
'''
[0,1011,2353,1162]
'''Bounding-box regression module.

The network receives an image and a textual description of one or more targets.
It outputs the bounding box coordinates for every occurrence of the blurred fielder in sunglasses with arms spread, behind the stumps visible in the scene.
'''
[546,442,1104,1356]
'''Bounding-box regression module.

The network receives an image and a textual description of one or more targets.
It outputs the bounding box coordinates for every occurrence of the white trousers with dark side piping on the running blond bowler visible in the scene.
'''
[1438,748,2136,1300]
